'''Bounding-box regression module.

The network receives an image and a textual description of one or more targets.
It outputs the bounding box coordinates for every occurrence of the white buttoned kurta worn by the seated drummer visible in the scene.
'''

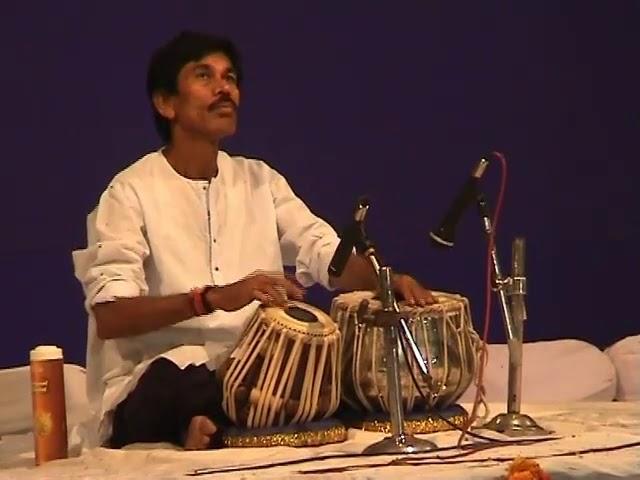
[73,151,339,445]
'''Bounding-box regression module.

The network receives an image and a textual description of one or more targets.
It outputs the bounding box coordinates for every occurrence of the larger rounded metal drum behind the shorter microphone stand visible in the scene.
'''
[331,292,481,413]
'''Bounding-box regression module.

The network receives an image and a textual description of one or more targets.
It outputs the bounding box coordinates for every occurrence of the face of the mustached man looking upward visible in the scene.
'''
[161,53,240,141]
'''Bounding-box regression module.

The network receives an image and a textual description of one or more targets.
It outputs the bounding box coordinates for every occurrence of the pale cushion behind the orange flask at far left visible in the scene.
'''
[0,364,89,435]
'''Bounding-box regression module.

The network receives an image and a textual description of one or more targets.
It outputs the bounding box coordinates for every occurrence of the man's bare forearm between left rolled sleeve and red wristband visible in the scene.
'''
[93,293,195,340]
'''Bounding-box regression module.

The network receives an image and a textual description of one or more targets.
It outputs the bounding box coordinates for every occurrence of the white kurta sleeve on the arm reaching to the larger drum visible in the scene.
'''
[271,170,340,289]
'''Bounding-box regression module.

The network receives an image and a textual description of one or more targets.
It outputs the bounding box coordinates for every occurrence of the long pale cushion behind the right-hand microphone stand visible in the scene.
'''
[460,340,616,405]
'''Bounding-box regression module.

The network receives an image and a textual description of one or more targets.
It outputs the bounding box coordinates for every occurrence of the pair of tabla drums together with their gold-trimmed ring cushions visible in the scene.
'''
[220,292,480,446]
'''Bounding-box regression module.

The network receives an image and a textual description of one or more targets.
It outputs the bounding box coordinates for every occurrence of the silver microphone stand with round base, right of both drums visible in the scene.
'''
[477,193,551,437]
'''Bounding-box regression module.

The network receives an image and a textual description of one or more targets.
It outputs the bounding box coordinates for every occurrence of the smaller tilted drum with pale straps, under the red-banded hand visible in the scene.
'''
[220,302,340,429]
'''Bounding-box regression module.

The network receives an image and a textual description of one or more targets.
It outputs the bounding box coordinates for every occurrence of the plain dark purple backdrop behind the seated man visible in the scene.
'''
[0,0,640,367]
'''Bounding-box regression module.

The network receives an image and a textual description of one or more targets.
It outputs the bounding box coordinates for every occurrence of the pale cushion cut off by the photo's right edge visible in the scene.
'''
[605,335,640,401]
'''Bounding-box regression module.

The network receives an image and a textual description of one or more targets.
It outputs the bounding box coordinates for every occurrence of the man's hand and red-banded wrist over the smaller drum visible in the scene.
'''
[206,271,304,312]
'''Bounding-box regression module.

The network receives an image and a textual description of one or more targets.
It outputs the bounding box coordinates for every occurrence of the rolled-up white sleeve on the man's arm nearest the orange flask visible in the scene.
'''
[73,181,149,306]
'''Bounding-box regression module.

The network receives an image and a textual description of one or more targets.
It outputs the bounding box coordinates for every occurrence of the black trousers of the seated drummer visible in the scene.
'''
[109,358,230,448]
